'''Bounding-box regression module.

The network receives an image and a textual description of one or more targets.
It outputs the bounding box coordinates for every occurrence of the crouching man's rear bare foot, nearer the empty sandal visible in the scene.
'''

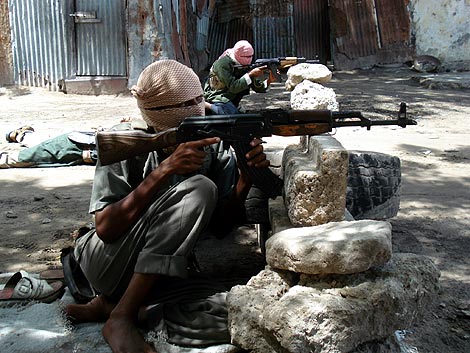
[65,295,116,324]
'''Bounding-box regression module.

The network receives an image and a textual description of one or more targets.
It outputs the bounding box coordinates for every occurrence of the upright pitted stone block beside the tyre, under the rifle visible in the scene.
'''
[282,135,349,226]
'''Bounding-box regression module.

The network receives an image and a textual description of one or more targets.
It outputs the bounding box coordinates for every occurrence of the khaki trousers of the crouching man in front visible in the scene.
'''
[75,175,217,298]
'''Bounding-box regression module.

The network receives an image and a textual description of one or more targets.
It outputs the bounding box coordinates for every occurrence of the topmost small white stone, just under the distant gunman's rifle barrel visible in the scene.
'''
[286,63,333,91]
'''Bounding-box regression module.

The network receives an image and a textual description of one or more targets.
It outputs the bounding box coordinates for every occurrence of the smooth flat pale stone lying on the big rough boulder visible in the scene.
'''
[266,220,392,274]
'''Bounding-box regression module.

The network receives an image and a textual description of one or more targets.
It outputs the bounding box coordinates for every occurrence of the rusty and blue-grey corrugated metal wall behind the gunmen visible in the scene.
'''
[8,0,412,89]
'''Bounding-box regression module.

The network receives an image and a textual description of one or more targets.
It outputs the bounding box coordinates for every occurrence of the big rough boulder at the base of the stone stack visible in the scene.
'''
[227,253,439,353]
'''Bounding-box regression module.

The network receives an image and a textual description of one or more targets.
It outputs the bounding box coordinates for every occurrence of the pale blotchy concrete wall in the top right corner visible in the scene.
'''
[409,0,470,70]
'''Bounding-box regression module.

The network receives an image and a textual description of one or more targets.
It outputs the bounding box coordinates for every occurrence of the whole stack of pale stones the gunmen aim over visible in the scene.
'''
[227,64,440,353]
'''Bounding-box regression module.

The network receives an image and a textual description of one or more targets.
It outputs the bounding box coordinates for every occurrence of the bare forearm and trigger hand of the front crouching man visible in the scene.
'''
[95,137,220,243]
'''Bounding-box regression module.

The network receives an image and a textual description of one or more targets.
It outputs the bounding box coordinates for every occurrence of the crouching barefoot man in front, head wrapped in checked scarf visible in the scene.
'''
[65,60,269,352]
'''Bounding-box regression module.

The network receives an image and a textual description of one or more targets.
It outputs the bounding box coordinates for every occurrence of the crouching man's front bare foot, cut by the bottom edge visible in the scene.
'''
[102,315,157,353]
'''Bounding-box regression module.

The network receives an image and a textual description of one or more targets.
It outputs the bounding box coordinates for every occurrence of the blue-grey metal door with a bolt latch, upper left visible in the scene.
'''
[70,0,127,77]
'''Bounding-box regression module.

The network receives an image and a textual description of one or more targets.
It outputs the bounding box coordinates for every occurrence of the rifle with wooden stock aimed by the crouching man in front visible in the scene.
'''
[96,103,416,198]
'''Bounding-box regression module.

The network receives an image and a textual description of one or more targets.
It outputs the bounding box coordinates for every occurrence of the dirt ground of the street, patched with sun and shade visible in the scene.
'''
[0,68,470,353]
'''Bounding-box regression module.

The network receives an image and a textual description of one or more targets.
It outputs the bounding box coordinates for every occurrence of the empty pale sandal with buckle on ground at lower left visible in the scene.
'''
[0,271,64,305]
